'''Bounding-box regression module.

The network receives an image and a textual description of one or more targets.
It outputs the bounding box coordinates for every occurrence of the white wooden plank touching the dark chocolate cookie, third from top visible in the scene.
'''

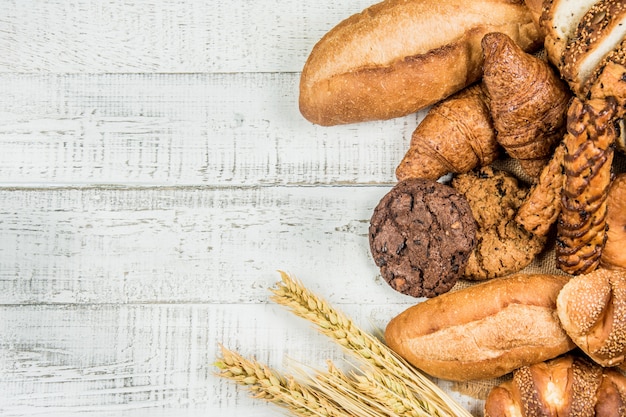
[0,186,420,304]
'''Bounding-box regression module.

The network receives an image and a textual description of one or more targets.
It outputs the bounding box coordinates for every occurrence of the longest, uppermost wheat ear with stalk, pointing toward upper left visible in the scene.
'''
[271,271,471,417]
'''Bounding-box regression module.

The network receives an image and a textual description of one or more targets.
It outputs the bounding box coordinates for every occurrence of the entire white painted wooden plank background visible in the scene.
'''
[0,0,478,417]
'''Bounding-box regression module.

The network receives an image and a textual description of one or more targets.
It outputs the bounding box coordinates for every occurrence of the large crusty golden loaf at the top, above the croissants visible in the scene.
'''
[299,0,543,125]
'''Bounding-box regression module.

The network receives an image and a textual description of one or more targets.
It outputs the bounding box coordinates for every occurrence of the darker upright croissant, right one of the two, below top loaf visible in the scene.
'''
[482,33,571,178]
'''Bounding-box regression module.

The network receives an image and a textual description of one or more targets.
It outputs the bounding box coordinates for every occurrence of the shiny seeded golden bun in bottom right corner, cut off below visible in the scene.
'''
[484,354,626,417]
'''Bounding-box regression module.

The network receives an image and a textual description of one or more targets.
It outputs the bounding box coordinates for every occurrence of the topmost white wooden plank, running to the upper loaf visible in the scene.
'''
[0,0,371,73]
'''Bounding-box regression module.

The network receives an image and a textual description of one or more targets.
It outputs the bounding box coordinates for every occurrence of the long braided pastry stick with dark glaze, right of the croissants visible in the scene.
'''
[556,97,617,275]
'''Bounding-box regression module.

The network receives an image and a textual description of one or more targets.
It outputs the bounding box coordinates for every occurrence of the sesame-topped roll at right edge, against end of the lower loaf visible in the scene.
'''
[557,268,626,366]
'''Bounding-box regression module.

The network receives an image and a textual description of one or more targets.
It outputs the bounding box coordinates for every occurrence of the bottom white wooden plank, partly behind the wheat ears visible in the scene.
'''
[0,303,464,417]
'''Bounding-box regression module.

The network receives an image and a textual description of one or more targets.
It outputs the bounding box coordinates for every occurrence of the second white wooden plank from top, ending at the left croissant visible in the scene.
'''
[0,74,423,187]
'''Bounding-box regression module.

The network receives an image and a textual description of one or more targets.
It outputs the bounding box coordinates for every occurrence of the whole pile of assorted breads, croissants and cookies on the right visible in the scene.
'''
[299,0,626,417]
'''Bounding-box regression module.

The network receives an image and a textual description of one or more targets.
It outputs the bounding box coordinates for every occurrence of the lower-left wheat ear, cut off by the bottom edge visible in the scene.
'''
[215,346,353,417]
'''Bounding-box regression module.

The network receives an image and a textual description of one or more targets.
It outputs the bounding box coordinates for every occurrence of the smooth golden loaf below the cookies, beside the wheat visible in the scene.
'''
[385,274,575,381]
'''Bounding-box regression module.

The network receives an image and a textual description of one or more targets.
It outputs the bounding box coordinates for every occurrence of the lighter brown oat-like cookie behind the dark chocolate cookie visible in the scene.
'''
[451,167,546,281]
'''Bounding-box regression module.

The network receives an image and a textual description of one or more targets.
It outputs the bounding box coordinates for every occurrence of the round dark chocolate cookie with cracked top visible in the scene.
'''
[369,178,476,297]
